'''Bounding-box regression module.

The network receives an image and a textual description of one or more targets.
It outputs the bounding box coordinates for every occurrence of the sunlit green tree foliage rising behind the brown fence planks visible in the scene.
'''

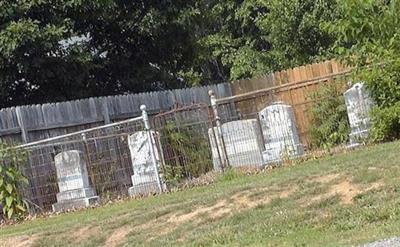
[198,0,336,80]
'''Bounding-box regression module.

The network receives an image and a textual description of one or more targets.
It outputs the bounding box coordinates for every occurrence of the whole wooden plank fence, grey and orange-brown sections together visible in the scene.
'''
[0,60,349,147]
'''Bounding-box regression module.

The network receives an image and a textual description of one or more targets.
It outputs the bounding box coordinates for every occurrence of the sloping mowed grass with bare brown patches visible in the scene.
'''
[0,142,400,246]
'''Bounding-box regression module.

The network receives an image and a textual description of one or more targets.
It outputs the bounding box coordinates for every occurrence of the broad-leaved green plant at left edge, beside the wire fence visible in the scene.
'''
[0,142,28,219]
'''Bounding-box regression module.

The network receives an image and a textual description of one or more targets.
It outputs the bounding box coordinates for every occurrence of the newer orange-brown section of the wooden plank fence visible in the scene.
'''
[219,60,350,145]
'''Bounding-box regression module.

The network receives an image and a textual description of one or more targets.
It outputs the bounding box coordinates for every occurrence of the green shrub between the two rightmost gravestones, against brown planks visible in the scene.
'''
[310,83,350,148]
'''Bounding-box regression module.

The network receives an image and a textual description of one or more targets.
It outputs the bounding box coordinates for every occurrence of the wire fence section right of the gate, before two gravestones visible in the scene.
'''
[210,72,349,168]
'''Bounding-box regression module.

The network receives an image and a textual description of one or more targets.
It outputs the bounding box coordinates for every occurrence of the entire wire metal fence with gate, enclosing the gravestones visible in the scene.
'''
[1,70,358,211]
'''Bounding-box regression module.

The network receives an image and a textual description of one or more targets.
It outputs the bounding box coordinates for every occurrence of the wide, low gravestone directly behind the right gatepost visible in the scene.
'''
[208,119,264,170]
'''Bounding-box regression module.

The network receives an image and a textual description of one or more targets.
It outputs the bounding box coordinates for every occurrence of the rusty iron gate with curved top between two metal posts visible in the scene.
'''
[153,104,222,185]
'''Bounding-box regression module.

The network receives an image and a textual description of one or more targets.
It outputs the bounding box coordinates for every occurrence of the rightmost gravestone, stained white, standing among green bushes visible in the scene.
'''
[344,83,374,146]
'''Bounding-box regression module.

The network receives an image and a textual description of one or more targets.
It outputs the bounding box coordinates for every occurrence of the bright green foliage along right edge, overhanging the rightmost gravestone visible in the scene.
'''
[327,0,400,141]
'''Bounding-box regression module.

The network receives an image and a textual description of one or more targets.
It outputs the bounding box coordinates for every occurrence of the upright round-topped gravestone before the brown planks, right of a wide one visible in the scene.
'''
[258,102,304,163]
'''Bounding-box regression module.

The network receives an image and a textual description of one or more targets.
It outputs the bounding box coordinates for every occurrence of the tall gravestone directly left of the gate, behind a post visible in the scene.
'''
[128,131,165,196]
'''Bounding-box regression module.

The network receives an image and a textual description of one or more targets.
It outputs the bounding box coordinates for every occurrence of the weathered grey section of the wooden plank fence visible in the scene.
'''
[0,83,232,143]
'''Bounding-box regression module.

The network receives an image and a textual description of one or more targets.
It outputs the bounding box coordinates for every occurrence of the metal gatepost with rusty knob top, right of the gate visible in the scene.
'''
[208,90,229,171]
